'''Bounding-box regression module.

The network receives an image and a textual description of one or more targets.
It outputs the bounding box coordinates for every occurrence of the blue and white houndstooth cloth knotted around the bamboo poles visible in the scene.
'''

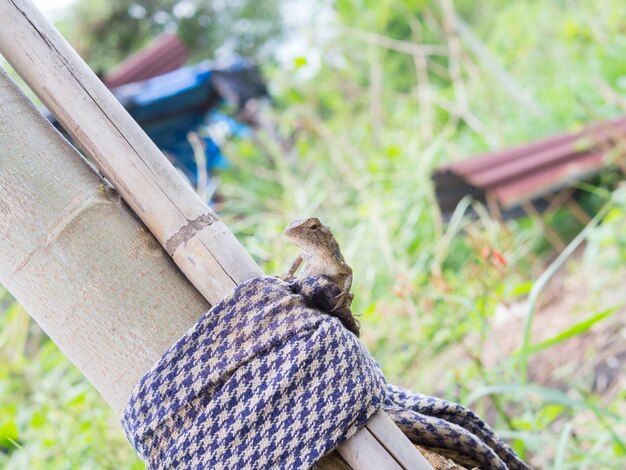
[122,277,528,470]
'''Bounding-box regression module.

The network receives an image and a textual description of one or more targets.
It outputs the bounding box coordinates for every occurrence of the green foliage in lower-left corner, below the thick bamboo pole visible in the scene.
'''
[0,288,144,470]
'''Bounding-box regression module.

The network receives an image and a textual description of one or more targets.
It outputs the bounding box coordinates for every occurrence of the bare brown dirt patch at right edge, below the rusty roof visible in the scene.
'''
[482,250,626,399]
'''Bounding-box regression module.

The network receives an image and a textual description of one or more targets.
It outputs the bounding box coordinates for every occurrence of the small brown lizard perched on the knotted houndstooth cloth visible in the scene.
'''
[283,217,353,311]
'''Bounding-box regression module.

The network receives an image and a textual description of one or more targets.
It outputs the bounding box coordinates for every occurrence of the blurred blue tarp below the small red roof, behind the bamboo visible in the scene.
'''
[48,60,267,182]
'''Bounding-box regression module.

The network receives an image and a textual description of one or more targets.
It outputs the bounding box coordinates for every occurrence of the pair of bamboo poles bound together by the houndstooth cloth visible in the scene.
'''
[0,0,432,469]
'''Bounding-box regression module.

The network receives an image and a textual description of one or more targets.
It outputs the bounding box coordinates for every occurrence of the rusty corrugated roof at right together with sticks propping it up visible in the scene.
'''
[432,117,626,250]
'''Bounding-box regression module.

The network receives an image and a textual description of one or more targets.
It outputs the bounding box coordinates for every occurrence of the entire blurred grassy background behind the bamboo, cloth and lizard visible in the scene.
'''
[0,0,626,469]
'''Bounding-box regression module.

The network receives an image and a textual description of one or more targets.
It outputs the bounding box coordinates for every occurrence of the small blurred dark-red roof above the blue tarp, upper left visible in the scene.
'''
[104,34,189,88]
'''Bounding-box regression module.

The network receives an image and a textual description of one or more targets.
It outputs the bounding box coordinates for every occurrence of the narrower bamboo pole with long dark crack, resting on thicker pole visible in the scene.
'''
[0,0,431,469]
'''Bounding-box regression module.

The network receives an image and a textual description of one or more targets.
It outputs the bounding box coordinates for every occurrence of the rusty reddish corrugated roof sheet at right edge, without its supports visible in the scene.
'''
[432,117,626,214]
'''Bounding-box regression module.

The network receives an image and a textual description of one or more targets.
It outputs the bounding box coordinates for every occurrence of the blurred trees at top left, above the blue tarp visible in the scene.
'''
[57,0,282,71]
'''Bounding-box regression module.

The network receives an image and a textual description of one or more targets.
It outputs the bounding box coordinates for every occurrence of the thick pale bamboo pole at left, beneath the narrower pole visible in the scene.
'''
[0,68,209,414]
